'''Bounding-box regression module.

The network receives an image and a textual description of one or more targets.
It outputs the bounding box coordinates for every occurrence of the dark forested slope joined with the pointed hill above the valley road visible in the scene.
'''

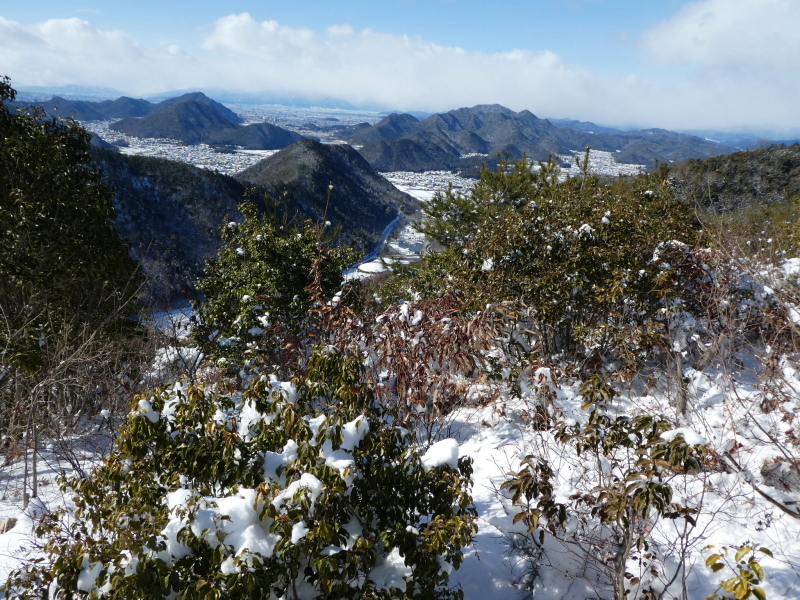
[93,140,417,302]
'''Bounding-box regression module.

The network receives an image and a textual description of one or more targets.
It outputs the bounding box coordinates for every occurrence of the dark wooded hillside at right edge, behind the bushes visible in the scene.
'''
[671,144,800,211]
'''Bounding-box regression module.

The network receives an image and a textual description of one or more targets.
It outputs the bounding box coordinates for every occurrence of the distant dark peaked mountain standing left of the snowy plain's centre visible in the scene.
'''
[109,99,239,144]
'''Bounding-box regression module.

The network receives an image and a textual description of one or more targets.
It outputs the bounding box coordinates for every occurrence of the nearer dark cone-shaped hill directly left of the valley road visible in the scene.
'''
[236,139,418,250]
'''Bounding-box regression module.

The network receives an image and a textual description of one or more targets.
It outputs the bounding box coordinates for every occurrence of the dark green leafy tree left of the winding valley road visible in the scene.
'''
[195,202,357,364]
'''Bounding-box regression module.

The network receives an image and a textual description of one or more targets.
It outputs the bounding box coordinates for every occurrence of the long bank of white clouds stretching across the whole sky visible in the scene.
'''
[0,9,800,134]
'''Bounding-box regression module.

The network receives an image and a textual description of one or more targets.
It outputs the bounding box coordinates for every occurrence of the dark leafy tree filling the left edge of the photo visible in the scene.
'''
[0,77,141,488]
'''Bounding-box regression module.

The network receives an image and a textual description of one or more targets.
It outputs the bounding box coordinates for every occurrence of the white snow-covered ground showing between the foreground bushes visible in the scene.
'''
[0,338,800,600]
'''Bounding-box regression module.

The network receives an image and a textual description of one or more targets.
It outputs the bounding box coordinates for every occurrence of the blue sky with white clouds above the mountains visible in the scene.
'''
[0,0,800,132]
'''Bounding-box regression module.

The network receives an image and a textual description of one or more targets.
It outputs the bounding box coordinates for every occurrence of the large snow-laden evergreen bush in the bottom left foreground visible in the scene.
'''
[4,347,475,599]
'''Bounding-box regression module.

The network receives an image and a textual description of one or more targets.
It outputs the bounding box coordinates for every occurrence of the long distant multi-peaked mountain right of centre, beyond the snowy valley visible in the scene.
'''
[339,104,733,171]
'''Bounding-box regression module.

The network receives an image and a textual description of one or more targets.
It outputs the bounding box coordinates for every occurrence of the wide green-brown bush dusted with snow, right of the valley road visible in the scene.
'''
[390,161,699,356]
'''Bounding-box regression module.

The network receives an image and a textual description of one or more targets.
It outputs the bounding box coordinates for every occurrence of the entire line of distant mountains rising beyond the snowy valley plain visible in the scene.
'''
[12,92,736,175]
